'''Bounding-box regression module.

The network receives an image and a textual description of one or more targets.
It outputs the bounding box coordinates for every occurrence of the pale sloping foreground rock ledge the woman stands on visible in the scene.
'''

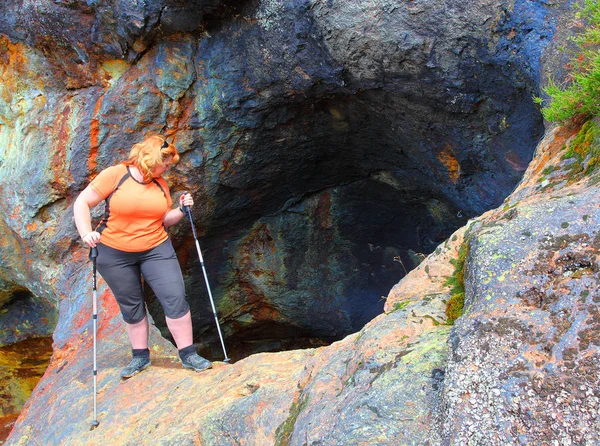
[8,120,600,445]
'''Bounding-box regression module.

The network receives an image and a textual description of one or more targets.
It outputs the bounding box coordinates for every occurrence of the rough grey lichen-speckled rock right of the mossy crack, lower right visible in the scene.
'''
[444,120,600,444]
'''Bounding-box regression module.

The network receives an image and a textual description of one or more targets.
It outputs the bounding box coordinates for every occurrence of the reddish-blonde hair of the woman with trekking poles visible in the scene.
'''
[123,135,179,182]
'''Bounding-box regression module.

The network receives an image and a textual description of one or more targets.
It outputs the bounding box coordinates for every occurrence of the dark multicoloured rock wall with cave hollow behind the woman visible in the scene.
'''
[0,0,561,350]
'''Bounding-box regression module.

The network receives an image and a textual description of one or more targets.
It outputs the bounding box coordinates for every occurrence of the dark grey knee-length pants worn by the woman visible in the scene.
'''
[96,239,190,324]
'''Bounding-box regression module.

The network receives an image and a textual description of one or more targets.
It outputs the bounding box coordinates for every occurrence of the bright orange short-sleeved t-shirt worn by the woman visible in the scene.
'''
[90,164,173,252]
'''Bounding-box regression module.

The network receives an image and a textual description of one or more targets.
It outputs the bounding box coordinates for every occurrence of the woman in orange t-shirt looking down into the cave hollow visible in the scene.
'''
[73,135,212,378]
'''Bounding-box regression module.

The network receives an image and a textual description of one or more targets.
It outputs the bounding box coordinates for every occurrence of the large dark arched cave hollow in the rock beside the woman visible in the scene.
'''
[150,81,544,359]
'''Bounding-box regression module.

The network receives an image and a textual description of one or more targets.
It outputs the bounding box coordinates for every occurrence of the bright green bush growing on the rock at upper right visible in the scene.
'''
[534,0,600,123]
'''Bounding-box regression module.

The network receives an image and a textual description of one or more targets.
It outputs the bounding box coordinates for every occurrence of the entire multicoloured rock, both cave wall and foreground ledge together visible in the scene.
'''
[0,0,600,445]
